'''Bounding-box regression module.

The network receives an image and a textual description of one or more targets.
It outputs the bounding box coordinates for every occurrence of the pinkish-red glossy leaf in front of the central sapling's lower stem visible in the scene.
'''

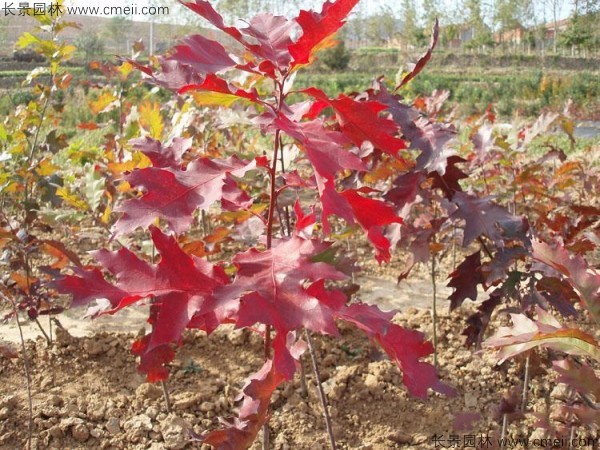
[215,236,347,334]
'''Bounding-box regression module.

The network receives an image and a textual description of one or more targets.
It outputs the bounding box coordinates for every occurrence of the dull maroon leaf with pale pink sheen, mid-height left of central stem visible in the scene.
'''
[113,157,256,234]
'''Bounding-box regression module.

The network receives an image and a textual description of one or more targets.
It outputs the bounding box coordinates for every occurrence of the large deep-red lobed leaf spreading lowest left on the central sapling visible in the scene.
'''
[53,227,229,380]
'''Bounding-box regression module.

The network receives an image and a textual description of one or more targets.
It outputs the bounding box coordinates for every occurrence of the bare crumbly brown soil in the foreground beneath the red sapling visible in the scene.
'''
[0,296,597,450]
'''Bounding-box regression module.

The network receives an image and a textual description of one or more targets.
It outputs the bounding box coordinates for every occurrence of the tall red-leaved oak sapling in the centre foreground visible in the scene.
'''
[54,0,464,449]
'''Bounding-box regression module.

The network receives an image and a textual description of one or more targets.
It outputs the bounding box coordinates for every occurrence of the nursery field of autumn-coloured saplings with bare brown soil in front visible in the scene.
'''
[0,0,600,450]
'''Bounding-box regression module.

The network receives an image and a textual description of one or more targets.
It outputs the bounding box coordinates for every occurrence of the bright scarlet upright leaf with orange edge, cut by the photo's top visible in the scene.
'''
[289,0,358,67]
